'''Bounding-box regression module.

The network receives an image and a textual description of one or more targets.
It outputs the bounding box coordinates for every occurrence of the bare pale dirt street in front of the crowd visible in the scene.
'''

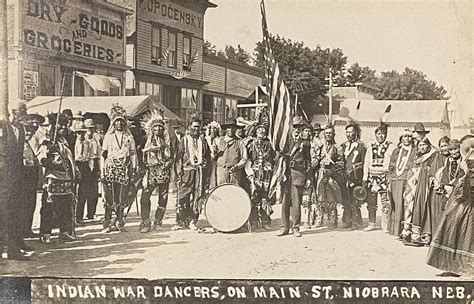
[0,191,470,280]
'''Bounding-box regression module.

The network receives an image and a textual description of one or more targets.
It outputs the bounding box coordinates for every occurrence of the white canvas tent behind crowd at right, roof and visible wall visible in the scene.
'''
[313,99,450,145]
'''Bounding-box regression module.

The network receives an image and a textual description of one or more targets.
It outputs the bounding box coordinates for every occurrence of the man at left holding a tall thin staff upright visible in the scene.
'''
[39,113,80,244]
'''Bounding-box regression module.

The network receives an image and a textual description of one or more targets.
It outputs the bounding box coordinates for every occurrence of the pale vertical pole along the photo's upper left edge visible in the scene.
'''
[0,0,8,120]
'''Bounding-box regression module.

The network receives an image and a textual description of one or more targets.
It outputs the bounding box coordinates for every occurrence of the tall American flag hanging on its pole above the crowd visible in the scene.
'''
[260,0,293,154]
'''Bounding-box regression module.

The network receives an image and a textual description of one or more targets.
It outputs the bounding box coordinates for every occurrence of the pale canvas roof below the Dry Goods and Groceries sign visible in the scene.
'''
[27,95,181,122]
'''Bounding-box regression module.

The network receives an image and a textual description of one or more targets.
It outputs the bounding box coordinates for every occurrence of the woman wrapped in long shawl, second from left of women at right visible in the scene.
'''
[401,138,438,246]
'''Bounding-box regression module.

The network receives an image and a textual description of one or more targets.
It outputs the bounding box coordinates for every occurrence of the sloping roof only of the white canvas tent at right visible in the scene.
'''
[336,99,449,126]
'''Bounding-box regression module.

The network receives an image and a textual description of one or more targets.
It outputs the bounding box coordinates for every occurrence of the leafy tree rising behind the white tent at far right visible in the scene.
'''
[376,68,446,100]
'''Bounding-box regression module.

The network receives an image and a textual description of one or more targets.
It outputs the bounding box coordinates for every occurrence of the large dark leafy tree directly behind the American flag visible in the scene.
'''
[255,35,347,117]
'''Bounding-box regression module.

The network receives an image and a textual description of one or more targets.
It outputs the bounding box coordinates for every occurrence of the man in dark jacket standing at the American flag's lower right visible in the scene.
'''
[277,117,313,237]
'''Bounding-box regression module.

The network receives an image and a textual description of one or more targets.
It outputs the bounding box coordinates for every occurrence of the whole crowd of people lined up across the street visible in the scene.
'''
[0,104,474,273]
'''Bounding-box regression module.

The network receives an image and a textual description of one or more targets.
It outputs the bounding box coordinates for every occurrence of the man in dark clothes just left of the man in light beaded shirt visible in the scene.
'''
[341,122,366,229]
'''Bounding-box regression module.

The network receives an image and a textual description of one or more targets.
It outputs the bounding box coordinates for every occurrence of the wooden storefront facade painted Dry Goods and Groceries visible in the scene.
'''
[7,0,133,103]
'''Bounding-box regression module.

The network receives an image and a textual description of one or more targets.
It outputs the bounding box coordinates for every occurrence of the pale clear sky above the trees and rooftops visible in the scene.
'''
[204,0,474,123]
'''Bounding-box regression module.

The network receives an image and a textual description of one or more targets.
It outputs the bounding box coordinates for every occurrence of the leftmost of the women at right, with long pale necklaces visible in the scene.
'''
[387,130,416,236]
